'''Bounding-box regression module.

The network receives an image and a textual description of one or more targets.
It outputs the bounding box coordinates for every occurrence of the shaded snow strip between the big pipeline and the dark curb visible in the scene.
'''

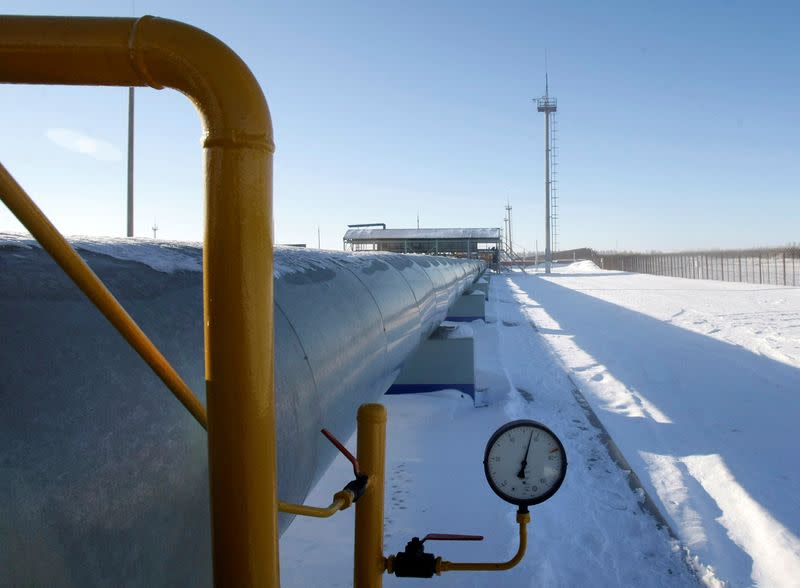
[281,277,700,587]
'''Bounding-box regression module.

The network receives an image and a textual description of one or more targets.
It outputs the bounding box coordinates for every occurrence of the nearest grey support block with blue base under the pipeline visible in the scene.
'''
[386,324,476,401]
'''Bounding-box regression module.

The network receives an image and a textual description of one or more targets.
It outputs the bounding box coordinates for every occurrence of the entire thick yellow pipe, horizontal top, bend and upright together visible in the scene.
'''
[0,16,280,586]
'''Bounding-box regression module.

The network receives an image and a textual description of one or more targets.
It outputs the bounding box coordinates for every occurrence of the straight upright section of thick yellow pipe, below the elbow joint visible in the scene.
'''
[203,146,280,586]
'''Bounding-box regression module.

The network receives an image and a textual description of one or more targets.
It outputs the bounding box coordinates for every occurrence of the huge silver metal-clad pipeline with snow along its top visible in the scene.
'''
[0,241,482,586]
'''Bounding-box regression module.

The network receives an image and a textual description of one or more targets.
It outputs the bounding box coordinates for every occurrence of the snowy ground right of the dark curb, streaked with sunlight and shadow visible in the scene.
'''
[506,262,800,587]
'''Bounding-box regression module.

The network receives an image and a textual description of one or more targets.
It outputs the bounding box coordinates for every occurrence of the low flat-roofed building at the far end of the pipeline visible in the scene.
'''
[344,224,502,264]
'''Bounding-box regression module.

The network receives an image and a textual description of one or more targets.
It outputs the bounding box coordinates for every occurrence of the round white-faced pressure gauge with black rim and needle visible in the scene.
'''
[483,420,567,506]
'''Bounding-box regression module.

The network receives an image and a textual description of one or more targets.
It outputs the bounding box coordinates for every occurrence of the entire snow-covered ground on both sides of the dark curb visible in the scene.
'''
[281,263,800,587]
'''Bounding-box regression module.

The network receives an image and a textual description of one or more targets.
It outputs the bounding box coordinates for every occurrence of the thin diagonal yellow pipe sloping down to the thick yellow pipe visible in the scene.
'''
[0,163,207,428]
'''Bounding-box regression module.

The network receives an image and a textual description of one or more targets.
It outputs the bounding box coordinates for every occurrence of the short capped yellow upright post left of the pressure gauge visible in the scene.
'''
[353,404,386,588]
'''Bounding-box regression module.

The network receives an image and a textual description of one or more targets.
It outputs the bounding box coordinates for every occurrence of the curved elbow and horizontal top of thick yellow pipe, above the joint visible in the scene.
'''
[0,15,275,153]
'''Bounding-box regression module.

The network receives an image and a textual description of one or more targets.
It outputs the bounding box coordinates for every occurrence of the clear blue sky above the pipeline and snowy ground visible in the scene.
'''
[0,0,800,250]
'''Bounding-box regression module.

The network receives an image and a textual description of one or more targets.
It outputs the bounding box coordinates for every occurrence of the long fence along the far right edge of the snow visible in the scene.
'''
[592,247,800,286]
